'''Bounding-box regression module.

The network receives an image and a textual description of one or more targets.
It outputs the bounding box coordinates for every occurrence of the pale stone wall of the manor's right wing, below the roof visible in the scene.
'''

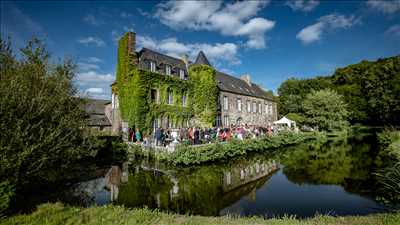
[219,91,277,127]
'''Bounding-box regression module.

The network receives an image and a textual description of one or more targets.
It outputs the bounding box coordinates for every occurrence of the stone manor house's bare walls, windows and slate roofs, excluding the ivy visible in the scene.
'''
[111,32,277,133]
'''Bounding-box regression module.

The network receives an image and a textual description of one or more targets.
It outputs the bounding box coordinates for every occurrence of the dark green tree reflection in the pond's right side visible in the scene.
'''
[281,135,382,200]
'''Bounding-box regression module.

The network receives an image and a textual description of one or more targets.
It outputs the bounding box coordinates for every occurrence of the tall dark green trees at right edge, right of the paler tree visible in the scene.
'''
[332,56,400,124]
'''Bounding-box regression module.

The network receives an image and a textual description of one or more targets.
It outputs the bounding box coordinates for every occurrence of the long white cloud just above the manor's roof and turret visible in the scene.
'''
[136,35,241,65]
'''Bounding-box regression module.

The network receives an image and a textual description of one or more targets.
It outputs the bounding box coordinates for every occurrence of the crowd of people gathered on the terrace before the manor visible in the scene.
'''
[129,124,277,146]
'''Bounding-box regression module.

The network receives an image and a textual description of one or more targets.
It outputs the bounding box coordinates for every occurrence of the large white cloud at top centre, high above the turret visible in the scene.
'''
[155,1,275,49]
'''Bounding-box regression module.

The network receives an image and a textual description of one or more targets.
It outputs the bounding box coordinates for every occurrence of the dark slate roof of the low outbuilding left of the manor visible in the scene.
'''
[84,99,111,126]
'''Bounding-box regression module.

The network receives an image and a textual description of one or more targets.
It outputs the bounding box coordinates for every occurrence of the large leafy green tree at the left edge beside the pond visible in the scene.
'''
[0,40,97,191]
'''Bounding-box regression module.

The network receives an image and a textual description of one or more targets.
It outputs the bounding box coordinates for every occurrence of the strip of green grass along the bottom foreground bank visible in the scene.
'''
[0,203,400,225]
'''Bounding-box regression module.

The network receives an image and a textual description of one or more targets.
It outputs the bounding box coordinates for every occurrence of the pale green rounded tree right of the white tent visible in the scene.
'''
[303,89,348,131]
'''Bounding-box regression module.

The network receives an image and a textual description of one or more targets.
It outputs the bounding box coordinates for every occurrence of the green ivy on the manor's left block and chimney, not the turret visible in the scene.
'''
[116,34,192,133]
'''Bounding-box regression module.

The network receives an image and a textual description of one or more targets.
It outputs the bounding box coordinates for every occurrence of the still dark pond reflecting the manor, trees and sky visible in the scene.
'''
[18,130,386,218]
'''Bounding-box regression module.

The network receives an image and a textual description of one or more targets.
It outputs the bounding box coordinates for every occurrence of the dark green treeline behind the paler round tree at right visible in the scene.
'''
[278,55,400,125]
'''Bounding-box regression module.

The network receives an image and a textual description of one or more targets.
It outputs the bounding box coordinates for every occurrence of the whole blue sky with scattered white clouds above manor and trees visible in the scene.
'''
[0,0,400,99]
